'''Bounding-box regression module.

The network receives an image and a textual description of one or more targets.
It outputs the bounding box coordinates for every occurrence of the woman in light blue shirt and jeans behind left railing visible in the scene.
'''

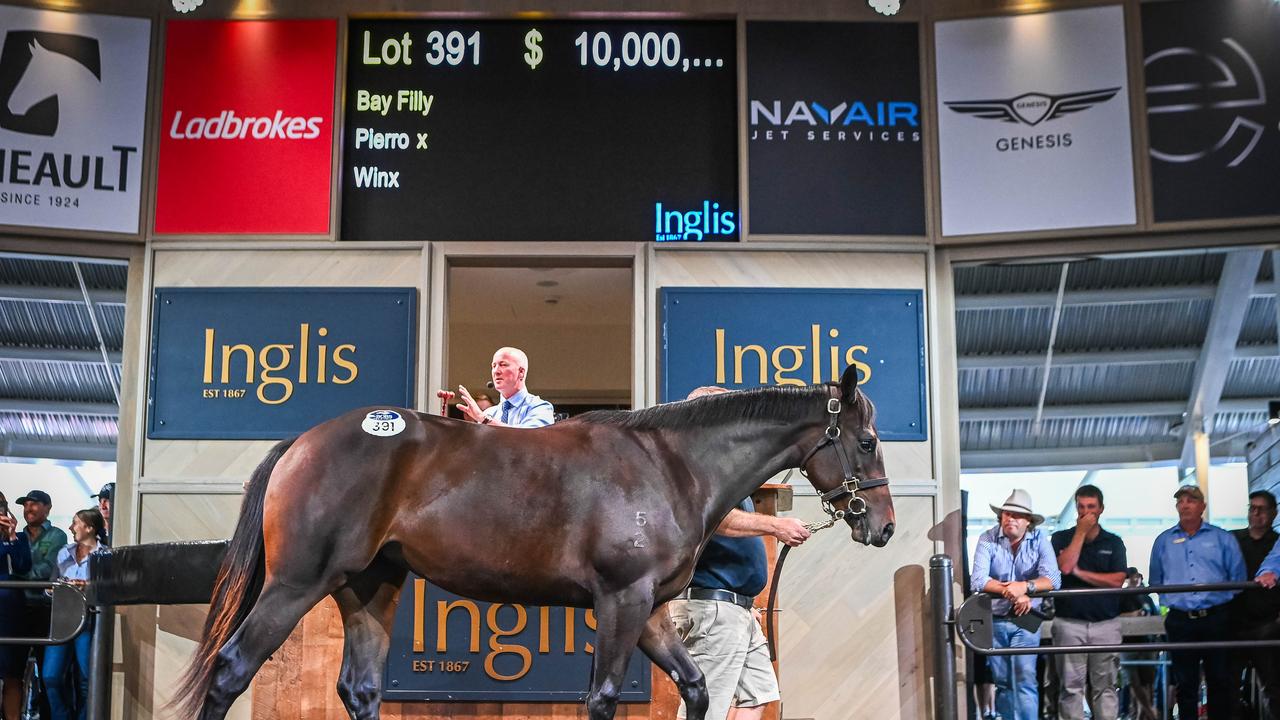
[44,507,104,720]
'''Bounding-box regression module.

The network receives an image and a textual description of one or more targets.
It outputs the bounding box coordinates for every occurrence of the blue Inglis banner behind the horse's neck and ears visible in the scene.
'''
[659,287,928,441]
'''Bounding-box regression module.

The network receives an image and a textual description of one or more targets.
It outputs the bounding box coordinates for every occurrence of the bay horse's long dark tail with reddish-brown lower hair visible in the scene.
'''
[172,438,298,717]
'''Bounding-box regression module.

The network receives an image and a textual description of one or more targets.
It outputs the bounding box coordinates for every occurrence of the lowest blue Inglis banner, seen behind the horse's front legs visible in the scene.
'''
[383,575,650,702]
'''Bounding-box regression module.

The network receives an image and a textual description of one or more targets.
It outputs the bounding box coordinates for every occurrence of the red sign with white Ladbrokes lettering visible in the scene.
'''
[156,20,338,233]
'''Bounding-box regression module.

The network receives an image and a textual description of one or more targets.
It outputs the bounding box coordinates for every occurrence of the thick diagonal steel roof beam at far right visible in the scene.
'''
[1181,250,1275,468]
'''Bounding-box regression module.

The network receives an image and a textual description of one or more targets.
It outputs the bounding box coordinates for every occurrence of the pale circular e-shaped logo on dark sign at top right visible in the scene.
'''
[1143,37,1267,168]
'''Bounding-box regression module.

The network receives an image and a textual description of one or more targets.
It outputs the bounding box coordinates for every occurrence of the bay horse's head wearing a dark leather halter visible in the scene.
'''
[800,365,893,547]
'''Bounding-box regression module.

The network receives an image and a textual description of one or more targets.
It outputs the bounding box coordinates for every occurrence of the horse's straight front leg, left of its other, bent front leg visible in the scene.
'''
[586,585,653,720]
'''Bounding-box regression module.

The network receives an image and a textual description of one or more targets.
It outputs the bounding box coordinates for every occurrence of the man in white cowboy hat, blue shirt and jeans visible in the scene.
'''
[970,488,1062,720]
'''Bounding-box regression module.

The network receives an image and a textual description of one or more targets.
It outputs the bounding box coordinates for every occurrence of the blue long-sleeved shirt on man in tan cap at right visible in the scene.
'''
[1147,523,1244,610]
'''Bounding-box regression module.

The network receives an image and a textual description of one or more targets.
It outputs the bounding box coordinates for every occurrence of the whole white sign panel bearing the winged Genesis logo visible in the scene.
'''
[936,5,1138,236]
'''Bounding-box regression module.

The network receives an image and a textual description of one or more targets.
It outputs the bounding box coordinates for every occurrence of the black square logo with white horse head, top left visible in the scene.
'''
[0,31,102,137]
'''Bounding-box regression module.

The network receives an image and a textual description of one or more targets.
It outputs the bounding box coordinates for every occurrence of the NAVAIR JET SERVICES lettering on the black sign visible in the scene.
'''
[751,100,920,142]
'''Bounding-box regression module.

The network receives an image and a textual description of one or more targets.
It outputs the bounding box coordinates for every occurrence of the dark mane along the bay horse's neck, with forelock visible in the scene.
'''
[576,384,876,430]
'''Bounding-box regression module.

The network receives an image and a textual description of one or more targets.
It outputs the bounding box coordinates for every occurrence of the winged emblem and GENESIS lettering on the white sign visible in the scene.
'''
[945,87,1120,152]
